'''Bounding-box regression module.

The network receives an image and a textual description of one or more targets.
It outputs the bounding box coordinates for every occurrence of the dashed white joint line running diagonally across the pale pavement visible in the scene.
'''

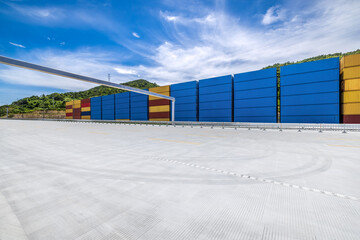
[151,156,360,202]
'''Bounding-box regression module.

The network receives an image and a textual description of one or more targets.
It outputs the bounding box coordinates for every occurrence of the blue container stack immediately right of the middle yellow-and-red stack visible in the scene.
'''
[170,81,198,121]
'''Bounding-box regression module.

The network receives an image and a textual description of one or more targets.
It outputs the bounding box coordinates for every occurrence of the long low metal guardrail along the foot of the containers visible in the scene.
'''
[3,118,360,133]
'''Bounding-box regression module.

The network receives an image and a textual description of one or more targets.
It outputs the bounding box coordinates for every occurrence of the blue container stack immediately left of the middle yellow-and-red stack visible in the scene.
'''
[130,92,149,120]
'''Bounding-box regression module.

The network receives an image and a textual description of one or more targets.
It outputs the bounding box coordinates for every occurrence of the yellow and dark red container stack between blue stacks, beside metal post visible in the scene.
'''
[149,86,170,121]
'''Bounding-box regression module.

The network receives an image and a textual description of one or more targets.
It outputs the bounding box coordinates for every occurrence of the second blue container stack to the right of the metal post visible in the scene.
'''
[199,75,233,122]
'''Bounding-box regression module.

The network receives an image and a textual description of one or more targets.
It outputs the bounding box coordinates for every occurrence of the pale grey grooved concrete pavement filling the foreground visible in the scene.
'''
[0,120,360,240]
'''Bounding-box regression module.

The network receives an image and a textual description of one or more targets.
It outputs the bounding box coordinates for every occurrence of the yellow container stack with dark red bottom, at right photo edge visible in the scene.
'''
[340,54,360,123]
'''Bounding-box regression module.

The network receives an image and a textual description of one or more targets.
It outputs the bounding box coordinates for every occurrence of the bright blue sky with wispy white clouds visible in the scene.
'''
[0,0,360,105]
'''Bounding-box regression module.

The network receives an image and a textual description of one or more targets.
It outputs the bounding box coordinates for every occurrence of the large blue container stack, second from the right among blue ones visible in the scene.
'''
[234,68,277,123]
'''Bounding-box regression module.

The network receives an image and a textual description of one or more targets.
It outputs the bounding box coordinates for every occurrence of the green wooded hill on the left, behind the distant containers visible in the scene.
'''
[0,79,158,117]
